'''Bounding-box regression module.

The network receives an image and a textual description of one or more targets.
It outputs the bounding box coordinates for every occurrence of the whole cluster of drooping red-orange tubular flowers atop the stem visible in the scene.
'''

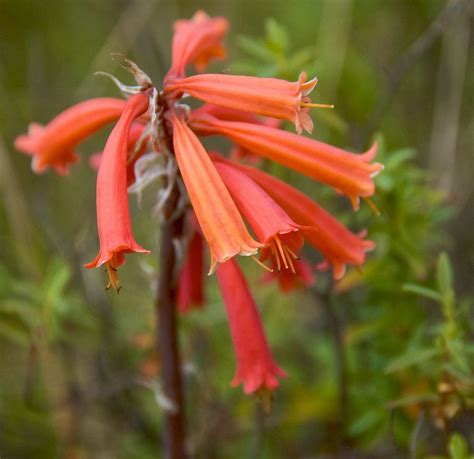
[15,11,382,393]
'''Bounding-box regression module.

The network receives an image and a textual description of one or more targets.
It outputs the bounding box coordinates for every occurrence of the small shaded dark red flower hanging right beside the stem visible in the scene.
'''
[177,231,204,314]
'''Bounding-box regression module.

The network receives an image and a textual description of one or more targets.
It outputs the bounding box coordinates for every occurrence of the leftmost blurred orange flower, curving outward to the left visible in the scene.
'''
[15,97,126,175]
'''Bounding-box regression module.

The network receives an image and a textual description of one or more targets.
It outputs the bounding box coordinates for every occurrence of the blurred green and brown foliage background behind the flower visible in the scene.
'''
[0,0,474,458]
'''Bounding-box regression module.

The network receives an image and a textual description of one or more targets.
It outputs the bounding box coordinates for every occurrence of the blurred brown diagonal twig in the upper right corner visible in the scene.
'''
[366,0,472,141]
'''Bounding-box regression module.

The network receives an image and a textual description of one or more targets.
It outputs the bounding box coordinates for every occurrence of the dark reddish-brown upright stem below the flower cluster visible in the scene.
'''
[156,181,185,459]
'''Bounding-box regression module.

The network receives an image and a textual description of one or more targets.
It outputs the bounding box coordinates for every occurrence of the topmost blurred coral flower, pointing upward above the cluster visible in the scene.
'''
[165,11,229,80]
